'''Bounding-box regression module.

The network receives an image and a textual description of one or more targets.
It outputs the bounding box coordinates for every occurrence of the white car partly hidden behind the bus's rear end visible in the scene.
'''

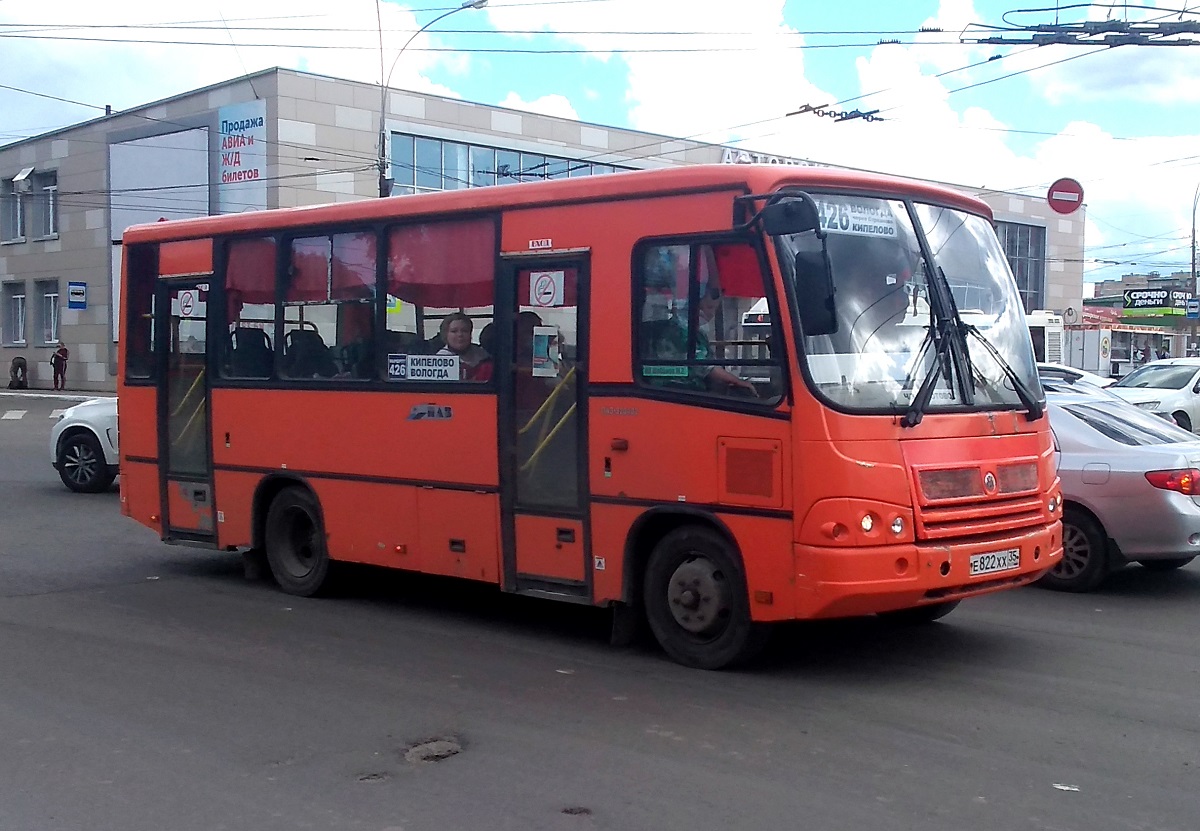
[50,399,118,494]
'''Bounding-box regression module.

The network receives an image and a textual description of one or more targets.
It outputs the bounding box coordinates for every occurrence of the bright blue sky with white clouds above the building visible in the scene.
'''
[0,0,1200,280]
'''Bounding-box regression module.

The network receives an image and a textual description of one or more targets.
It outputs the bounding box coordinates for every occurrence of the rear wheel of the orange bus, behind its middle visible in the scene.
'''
[266,488,330,597]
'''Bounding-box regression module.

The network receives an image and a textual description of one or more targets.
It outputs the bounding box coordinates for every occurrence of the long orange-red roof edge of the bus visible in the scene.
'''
[124,165,991,244]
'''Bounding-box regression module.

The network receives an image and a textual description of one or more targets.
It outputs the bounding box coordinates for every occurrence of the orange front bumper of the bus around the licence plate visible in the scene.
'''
[794,521,1062,620]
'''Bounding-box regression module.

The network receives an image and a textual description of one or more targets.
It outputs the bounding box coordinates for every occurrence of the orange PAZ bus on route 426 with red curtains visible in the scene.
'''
[119,166,1062,668]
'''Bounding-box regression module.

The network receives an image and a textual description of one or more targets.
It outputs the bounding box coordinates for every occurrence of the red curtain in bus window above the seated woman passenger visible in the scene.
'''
[388,219,496,309]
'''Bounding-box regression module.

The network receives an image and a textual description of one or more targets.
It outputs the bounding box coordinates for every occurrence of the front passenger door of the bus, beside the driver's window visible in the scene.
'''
[498,255,592,600]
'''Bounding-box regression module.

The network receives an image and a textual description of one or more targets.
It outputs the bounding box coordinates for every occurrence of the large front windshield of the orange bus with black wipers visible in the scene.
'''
[776,193,1044,412]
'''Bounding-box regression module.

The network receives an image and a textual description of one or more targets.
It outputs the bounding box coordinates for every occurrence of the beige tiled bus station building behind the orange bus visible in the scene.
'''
[0,68,1084,391]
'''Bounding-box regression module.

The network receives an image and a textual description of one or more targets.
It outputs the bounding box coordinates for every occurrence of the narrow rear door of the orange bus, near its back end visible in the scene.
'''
[155,277,216,542]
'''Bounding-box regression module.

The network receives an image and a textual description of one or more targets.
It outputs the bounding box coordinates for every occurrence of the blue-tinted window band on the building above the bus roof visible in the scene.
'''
[391,133,629,196]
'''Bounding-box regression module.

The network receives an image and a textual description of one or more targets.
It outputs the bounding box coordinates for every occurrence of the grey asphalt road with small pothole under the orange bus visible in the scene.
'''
[0,396,1200,831]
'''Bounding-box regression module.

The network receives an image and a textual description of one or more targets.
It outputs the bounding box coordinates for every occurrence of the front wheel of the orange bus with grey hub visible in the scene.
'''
[643,527,769,669]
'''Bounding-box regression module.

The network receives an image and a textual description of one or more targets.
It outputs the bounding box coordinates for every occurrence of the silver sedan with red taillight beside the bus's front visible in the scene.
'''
[1042,389,1200,592]
